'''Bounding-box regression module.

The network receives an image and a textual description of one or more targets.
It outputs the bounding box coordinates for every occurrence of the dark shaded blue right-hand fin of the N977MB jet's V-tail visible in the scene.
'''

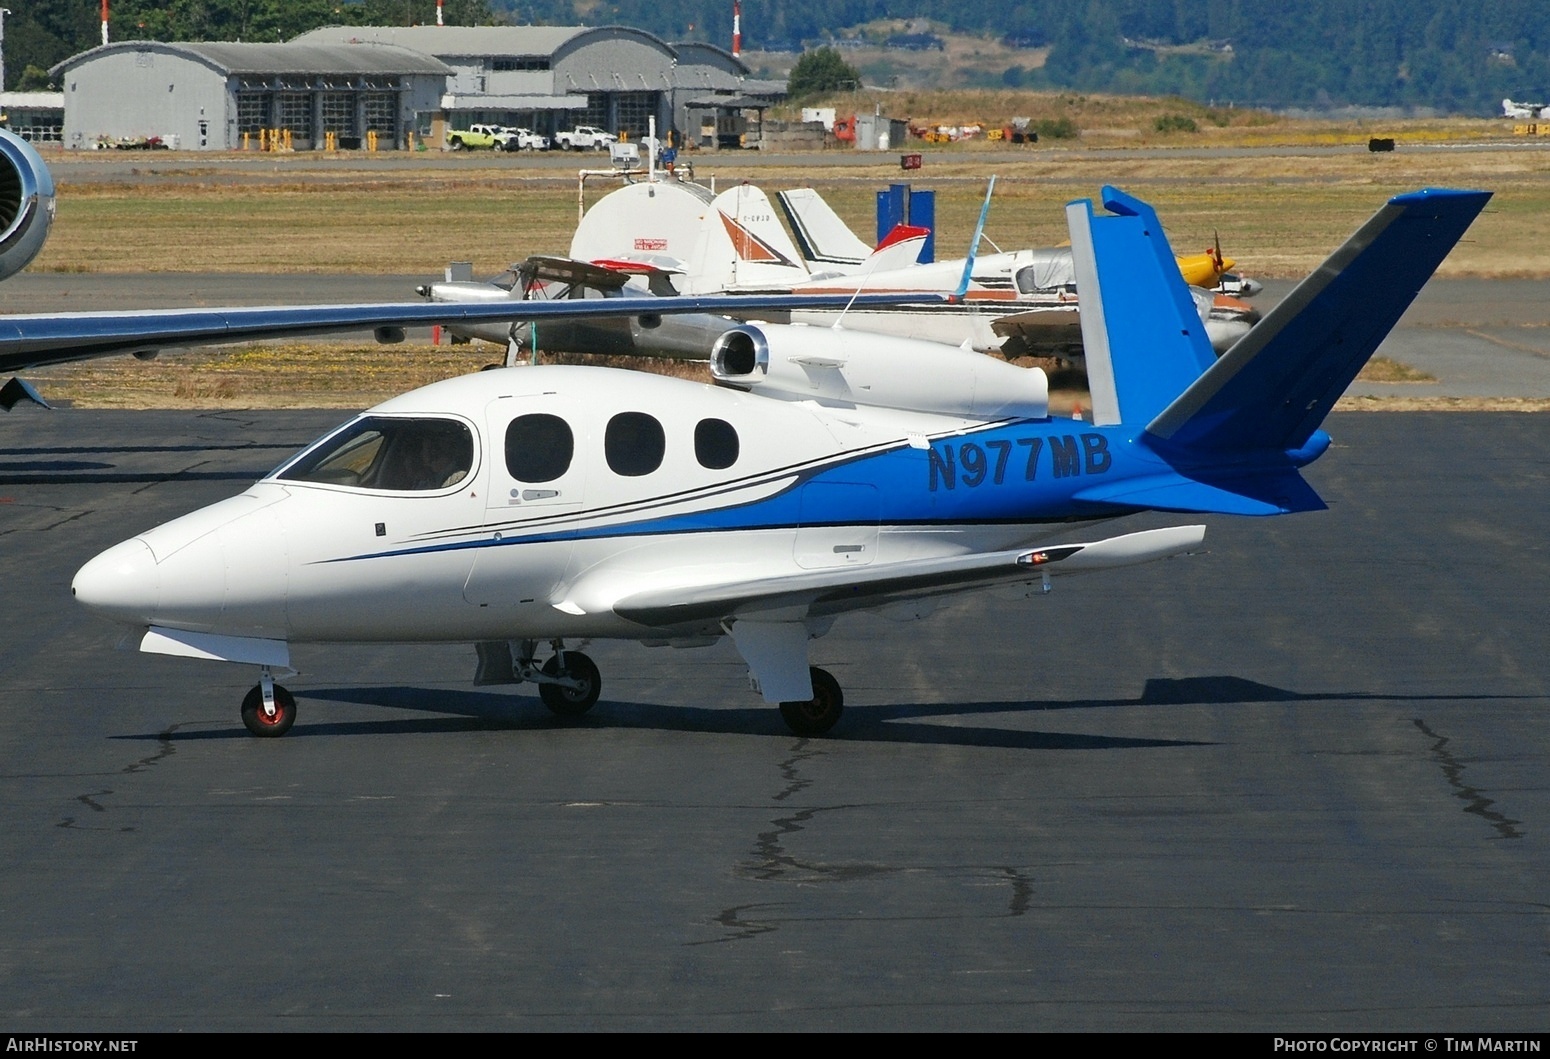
[1142,188,1491,456]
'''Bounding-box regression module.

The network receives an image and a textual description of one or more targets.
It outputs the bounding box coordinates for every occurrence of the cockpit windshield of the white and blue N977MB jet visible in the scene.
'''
[276,416,474,492]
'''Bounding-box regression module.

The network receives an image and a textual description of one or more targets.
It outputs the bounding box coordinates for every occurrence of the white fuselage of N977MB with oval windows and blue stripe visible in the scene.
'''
[74,367,1079,643]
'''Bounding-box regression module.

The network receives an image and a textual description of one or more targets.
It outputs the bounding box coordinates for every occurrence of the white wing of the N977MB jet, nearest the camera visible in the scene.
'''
[614,526,1206,628]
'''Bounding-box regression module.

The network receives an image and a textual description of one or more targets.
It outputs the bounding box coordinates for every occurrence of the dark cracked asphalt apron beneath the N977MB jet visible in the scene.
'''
[0,408,1550,1034]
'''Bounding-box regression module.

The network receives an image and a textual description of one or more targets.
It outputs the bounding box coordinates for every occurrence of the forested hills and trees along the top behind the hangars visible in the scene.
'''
[5,0,1550,113]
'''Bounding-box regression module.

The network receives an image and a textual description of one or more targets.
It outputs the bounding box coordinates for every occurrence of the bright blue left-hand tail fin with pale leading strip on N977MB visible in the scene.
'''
[1066,188,1215,428]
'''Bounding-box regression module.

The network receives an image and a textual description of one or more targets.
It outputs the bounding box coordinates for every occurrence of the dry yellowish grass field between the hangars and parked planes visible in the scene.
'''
[33,143,1550,278]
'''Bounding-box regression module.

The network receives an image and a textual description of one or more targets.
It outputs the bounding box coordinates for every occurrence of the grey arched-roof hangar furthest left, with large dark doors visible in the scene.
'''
[50,40,451,150]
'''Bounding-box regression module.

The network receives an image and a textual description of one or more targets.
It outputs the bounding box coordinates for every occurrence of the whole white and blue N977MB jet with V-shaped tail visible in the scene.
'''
[69,188,1490,735]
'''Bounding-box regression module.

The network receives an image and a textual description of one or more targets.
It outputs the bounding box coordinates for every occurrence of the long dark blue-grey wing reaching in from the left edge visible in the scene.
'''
[0,291,946,372]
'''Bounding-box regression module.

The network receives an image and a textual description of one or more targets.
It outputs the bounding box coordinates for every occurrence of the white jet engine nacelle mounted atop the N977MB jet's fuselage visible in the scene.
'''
[710,324,1049,419]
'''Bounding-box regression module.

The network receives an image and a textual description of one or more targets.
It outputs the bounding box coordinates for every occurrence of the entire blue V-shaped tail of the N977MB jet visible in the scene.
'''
[1066,188,1491,515]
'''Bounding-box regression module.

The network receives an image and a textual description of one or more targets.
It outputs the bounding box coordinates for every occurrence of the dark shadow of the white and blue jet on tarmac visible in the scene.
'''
[118,676,1516,750]
